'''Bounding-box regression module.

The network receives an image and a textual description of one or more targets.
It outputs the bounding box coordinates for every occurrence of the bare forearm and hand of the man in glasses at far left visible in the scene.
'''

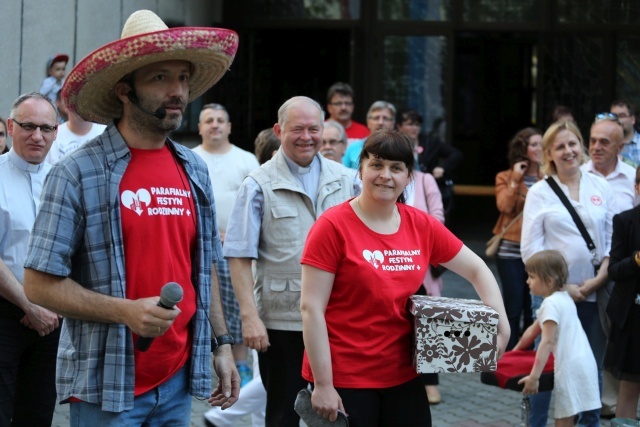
[0,259,60,337]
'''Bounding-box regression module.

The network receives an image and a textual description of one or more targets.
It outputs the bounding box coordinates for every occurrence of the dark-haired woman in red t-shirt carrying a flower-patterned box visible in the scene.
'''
[301,130,509,427]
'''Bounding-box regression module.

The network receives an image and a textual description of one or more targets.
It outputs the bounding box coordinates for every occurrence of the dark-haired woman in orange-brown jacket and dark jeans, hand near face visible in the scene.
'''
[493,127,542,351]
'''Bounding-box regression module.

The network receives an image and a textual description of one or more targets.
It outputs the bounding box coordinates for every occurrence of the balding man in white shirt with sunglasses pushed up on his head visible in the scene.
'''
[581,113,636,212]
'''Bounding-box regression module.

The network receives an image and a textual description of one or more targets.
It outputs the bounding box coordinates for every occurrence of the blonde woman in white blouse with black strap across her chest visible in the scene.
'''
[520,121,615,426]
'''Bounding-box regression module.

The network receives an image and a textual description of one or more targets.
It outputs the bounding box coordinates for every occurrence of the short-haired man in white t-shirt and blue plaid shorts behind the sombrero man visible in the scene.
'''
[193,104,260,386]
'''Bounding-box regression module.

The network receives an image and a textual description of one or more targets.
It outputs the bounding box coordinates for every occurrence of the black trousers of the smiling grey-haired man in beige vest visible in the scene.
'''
[258,329,307,427]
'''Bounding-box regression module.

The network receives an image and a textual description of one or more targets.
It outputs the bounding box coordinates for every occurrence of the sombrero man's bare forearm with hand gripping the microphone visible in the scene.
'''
[24,268,180,337]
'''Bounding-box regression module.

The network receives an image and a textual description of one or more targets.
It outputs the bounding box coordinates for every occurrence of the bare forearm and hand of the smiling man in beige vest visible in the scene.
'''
[229,258,270,351]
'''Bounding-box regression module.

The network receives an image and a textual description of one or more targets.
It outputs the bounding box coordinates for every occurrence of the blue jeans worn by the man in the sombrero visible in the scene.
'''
[70,361,191,427]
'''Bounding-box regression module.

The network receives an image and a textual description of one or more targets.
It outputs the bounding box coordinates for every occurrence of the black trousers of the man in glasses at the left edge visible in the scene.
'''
[0,310,60,427]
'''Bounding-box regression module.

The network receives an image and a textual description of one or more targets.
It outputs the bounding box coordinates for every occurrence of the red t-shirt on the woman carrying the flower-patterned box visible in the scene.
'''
[301,202,462,388]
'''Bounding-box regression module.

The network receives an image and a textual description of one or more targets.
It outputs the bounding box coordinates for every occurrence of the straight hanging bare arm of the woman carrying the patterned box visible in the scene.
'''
[300,264,344,421]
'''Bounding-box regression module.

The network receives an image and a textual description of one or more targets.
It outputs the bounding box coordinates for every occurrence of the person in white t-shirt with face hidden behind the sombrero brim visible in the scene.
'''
[47,111,107,165]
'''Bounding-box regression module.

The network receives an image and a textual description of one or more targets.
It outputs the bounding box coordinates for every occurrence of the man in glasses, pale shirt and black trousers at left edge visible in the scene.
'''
[0,92,60,427]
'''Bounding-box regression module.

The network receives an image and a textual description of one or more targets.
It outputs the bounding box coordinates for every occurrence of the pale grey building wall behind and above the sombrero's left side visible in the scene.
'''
[0,0,222,140]
